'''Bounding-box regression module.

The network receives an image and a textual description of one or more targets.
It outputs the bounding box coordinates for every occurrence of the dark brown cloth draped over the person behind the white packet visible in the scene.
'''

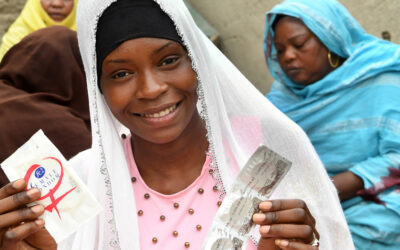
[0,26,91,186]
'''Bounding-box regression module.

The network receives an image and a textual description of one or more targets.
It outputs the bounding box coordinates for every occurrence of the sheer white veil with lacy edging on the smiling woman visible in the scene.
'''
[71,0,353,249]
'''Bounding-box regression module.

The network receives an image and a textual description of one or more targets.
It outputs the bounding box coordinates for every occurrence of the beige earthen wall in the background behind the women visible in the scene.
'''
[0,0,400,93]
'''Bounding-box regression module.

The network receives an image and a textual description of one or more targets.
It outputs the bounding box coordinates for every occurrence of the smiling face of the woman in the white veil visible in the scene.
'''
[101,38,197,144]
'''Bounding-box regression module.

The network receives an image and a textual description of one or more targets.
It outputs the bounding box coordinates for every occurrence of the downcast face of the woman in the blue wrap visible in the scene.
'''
[275,16,333,85]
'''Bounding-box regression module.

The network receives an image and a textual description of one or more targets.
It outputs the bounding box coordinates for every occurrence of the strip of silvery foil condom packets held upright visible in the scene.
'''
[202,145,292,250]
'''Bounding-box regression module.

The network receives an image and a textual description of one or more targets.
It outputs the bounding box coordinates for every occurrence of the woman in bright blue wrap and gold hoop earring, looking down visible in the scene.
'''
[265,0,400,250]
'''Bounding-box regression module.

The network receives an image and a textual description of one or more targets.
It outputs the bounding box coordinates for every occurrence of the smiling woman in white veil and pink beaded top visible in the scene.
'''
[0,0,353,250]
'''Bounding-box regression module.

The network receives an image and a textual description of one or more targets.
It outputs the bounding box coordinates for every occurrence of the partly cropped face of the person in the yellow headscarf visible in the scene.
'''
[40,0,74,22]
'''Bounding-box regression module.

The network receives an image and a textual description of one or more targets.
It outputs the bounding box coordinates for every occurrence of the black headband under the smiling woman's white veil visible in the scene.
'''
[96,0,183,88]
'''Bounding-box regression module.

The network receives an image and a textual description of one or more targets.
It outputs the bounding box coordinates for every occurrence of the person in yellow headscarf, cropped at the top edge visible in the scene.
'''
[0,0,78,62]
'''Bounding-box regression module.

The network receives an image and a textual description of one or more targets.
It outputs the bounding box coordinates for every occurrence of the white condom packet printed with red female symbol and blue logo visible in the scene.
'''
[1,130,102,243]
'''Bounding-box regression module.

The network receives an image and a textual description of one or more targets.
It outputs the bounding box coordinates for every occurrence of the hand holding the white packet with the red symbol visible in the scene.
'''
[0,179,57,250]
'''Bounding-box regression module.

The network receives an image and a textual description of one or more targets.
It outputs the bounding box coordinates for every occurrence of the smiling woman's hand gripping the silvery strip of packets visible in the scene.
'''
[253,200,319,250]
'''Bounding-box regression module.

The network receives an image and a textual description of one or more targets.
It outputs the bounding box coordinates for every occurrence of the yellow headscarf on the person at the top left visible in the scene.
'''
[0,0,78,61]
